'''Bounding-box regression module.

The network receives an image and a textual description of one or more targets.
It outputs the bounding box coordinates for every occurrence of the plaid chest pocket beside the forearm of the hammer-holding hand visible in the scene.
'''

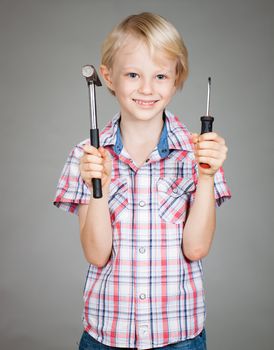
[108,178,128,223]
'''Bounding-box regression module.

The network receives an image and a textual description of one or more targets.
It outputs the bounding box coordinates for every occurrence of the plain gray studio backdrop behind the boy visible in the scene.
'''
[0,0,274,350]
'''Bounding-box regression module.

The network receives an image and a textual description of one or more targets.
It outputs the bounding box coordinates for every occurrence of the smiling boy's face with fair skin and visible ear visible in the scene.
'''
[101,37,176,121]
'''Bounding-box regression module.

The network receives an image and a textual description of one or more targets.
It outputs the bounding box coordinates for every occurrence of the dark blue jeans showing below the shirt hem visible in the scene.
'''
[79,330,206,350]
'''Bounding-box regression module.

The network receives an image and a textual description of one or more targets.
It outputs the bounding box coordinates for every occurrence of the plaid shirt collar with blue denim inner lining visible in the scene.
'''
[100,110,193,158]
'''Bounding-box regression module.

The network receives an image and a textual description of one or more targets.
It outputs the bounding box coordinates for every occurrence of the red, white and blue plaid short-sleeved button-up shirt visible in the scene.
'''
[54,111,230,349]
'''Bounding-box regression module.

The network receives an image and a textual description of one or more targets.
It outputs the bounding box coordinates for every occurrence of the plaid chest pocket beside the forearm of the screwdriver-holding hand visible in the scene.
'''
[157,177,196,224]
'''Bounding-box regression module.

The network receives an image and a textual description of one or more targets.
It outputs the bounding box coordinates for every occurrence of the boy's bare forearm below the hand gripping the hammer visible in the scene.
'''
[80,191,112,267]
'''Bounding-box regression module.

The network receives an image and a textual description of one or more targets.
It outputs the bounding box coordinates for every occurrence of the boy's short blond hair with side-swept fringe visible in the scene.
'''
[101,12,188,93]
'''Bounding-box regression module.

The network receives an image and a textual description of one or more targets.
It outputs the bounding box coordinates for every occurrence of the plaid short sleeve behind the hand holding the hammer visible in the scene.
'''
[53,143,90,214]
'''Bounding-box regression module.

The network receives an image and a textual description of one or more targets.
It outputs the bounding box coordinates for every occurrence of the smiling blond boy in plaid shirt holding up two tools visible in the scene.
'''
[54,13,230,350]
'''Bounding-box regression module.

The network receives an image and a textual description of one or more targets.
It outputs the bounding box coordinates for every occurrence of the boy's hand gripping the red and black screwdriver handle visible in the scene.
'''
[191,132,228,176]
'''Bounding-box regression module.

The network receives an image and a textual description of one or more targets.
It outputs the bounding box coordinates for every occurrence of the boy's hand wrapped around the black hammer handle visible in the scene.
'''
[80,145,112,190]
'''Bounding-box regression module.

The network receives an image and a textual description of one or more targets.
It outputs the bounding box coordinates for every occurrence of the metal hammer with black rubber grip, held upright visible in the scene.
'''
[82,64,102,198]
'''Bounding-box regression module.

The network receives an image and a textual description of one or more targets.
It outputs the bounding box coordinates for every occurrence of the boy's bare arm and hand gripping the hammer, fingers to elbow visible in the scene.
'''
[79,145,112,267]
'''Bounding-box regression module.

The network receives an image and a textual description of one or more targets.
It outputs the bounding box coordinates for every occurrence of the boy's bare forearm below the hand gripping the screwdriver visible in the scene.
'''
[183,176,216,260]
